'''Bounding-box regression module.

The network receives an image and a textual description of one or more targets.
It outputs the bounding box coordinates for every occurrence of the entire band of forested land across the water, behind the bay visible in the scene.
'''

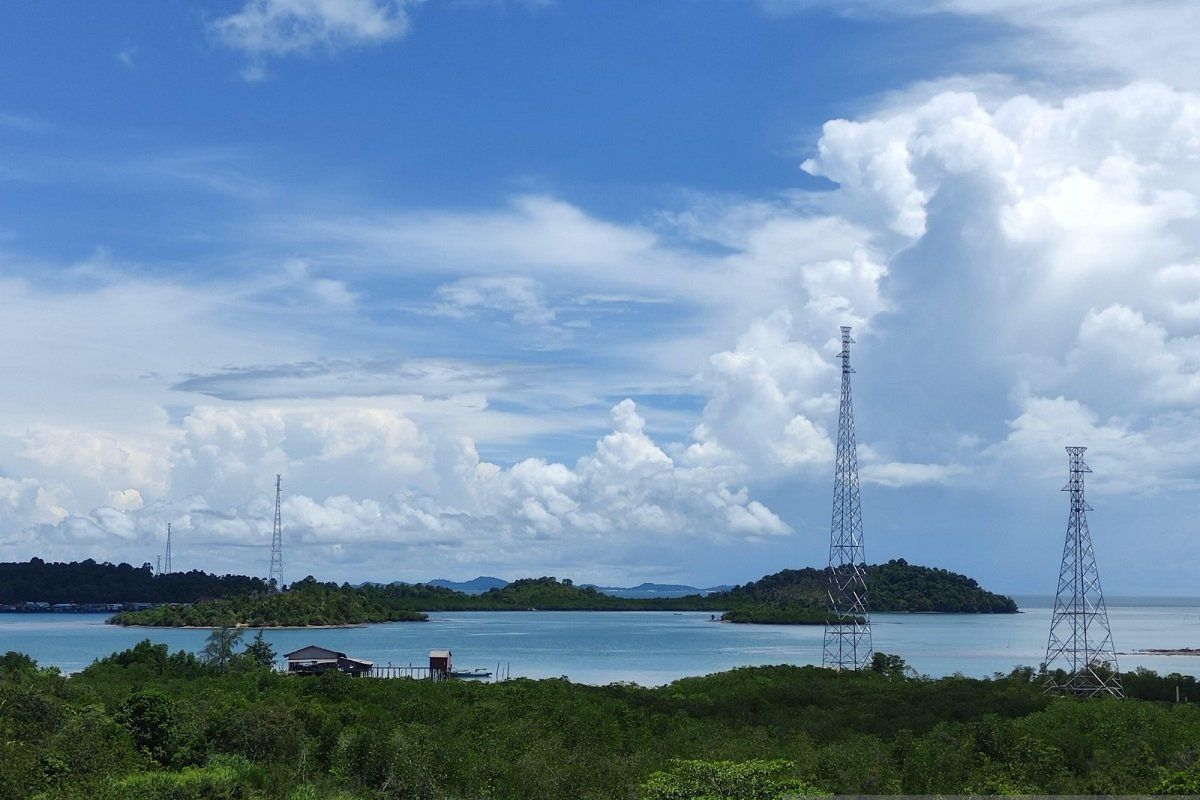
[0,559,1018,627]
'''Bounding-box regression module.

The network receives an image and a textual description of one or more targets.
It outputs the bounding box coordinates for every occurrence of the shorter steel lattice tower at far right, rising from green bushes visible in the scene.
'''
[1045,447,1124,697]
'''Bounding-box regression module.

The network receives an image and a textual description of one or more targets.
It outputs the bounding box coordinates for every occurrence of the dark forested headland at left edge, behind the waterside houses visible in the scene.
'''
[0,558,266,603]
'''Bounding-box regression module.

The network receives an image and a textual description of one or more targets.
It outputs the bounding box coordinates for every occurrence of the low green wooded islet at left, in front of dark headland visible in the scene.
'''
[109,578,427,627]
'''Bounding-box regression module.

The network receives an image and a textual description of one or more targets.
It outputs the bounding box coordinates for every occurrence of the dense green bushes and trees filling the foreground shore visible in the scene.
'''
[0,632,1200,800]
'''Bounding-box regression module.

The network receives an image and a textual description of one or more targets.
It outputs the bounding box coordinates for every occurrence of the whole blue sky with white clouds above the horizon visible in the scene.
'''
[0,0,1200,595]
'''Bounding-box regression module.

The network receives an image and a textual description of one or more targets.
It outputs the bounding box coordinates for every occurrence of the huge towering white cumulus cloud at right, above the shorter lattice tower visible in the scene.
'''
[804,77,1200,503]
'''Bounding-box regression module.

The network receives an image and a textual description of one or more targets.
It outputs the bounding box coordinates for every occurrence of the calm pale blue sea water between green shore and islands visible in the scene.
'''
[0,597,1200,686]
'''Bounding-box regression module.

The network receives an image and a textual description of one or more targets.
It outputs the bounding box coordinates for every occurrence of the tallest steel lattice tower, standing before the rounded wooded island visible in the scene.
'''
[822,325,871,669]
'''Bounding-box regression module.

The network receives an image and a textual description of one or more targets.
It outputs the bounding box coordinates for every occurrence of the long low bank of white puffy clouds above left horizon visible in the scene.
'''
[14,399,790,577]
